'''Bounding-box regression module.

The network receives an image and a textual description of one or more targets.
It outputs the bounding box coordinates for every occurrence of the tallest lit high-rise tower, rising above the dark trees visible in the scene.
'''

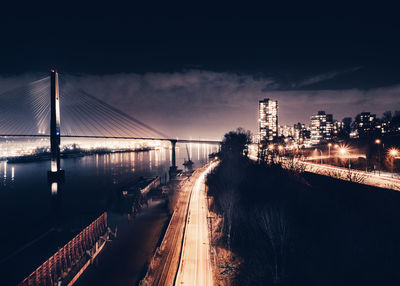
[258,98,278,141]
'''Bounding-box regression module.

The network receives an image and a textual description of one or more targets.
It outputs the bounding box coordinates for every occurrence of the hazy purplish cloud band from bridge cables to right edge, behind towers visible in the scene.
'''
[64,70,400,138]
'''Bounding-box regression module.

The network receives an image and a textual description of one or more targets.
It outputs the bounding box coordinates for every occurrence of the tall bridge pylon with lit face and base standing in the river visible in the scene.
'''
[47,69,64,183]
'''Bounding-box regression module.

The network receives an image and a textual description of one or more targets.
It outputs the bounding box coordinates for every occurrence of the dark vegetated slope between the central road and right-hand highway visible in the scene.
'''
[207,129,400,285]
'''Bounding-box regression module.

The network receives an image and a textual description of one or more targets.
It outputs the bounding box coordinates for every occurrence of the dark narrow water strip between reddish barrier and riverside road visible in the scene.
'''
[75,201,170,286]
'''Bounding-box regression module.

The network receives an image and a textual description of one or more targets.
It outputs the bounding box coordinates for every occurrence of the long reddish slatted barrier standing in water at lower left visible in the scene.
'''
[18,212,107,286]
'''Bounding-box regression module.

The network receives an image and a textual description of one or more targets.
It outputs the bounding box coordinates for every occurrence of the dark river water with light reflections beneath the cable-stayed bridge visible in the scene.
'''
[0,144,216,285]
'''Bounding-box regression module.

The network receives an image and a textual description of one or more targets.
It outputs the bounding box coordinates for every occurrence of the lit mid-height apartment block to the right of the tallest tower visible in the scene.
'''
[311,111,333,145]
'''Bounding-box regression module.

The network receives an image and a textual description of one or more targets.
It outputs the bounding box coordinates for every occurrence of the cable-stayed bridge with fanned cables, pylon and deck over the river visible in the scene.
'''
[0,70,220,180]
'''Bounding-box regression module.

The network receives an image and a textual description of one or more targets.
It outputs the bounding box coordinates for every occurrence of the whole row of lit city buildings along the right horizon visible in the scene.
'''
[252,94,400,149]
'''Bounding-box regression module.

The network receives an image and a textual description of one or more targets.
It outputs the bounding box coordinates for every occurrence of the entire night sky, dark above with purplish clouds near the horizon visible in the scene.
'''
[0,1,400,139]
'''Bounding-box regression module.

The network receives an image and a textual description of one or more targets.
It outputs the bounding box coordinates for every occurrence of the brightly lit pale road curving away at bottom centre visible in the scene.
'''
[175,163,216,285]
